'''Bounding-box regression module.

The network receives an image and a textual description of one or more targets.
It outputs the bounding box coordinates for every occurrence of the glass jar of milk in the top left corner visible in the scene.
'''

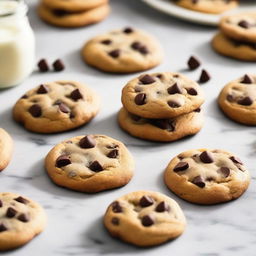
[0,0,35,89]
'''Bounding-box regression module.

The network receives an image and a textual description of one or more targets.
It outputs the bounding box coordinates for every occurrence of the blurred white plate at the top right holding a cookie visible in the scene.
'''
[142,0,256,26]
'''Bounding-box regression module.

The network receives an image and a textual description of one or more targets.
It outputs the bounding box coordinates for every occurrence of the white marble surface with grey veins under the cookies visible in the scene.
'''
[0,0,256,256]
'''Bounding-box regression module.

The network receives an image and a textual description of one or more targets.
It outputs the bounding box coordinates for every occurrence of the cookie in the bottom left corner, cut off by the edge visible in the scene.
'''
[0,192,46,251]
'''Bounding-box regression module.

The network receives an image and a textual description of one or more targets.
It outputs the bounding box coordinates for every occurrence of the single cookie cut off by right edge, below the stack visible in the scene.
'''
[218,75,256,125]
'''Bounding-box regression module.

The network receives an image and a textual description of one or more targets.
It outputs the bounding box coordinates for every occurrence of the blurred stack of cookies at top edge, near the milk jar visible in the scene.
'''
[38,0,110,27]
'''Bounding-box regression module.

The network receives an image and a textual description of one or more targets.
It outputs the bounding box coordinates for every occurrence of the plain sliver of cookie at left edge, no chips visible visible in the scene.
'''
[0,128,13,171]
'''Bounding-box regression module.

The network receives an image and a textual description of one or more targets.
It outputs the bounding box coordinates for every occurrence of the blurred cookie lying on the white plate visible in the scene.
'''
[174,0,238,14]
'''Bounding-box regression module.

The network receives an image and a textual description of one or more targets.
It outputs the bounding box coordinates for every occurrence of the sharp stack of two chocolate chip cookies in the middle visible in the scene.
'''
[118,72,204,142]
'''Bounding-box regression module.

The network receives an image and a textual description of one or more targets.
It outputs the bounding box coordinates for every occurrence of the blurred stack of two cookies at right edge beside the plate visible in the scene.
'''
[212,12,256,61]
